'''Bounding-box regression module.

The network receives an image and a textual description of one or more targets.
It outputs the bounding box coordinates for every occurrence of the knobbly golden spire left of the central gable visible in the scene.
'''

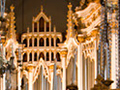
[7,5,16,39]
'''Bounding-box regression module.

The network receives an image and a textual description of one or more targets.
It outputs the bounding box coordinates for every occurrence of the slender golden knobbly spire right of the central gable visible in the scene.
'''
[67,3,75,39]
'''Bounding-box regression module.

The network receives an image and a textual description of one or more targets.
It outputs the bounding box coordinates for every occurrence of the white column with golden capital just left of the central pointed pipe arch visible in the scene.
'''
[28,66,33,90]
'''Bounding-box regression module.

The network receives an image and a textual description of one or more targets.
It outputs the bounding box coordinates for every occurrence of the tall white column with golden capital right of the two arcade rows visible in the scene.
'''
[60,48,67,90]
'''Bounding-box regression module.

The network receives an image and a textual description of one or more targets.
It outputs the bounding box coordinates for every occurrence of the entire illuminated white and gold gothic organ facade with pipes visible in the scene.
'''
[1,0,119,90]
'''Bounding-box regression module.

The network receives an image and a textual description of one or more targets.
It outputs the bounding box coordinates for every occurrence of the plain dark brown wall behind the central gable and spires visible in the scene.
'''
[6,0,80,34]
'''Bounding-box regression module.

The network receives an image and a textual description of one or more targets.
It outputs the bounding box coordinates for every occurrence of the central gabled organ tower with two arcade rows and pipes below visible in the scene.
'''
[21,6,62,90]
